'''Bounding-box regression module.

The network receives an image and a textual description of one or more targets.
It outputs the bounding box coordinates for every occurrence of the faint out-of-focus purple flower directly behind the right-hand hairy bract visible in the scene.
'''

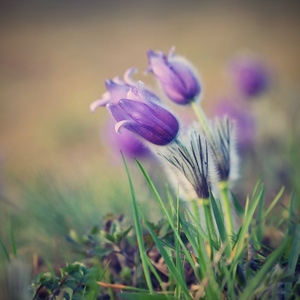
[211,99,255,150]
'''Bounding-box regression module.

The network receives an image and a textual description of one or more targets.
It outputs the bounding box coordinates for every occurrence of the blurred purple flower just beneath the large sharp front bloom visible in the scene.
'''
[104,117,150,158]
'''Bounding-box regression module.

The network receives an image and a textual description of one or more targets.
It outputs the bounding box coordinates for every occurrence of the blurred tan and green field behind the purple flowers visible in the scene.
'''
[0,0,300,259]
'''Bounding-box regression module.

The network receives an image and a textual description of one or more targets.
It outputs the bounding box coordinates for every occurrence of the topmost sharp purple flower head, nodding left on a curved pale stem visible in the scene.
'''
[147,47,201,104]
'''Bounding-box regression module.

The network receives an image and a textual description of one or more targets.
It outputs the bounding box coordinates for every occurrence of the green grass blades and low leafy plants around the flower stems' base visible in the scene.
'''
[25,157,300,300]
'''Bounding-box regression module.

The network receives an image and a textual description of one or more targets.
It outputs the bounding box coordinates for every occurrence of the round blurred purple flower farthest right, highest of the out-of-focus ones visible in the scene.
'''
[229,56,270,97]
